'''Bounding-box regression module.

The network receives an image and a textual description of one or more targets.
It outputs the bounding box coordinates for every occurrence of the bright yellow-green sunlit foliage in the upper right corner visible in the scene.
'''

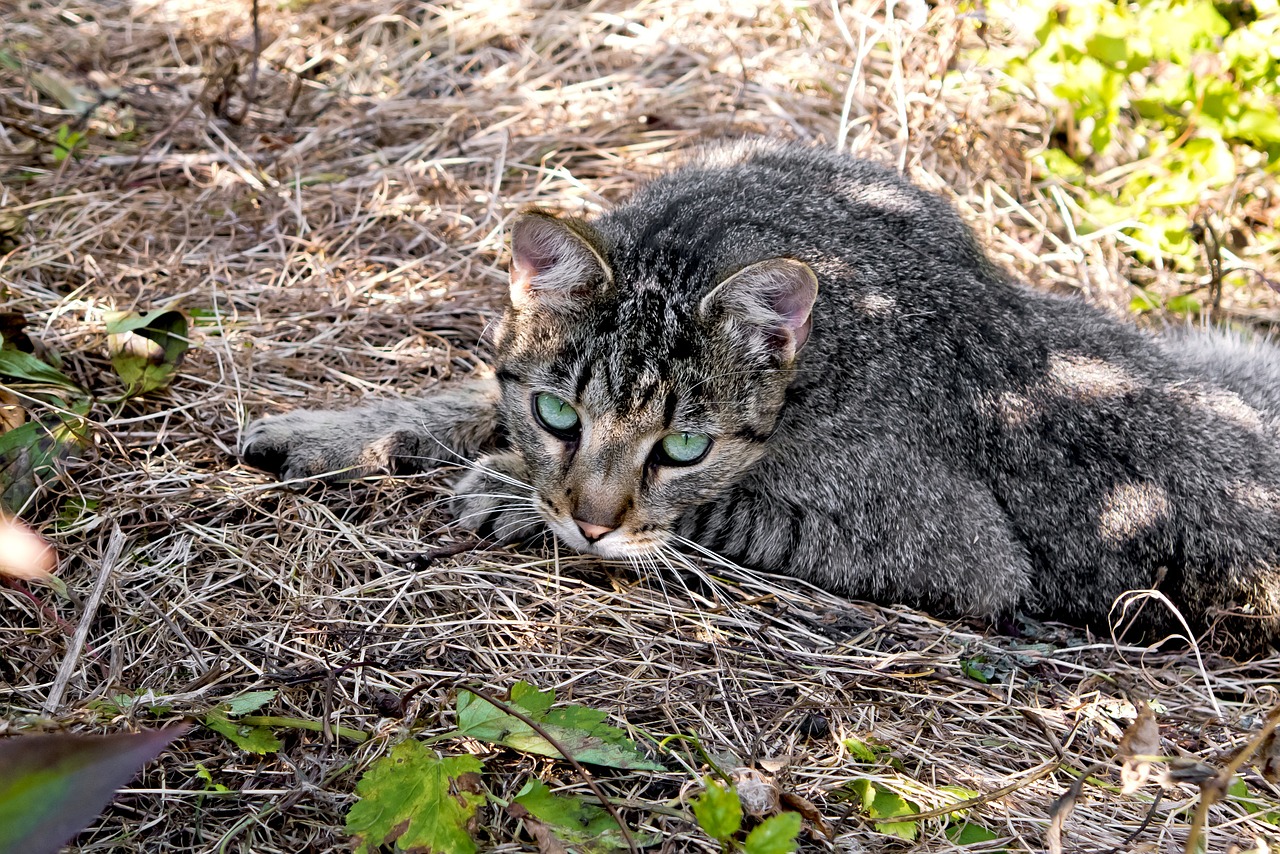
[996,0,1280,279]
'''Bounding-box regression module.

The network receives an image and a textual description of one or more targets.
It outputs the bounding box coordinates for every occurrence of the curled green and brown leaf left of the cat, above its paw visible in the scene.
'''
[106,309,191,396]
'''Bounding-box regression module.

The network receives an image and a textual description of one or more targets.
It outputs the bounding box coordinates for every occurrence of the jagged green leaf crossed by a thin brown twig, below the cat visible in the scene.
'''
[457,682,663,771]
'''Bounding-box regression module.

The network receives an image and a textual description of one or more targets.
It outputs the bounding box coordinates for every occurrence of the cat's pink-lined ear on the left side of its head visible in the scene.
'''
[511,211,612,310]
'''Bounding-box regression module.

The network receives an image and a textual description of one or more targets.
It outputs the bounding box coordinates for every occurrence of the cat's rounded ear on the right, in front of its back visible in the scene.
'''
[699,257,818,361]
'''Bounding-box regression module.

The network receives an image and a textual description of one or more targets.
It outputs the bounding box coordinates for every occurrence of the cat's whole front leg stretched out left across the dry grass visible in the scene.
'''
[241,376,499,480]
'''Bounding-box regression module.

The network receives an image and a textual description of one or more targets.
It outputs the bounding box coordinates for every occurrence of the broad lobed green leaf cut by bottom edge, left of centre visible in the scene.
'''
[347,740,484,854]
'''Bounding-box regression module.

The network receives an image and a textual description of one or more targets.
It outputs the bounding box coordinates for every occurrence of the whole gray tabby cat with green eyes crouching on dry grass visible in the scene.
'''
[244,141,1280,648]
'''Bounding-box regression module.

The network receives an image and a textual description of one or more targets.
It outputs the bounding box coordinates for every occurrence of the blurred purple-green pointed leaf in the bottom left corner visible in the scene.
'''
[0,727,187,853]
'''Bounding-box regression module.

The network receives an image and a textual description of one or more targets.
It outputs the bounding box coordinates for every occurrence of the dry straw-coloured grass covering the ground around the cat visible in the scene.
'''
[0,0,1280,854]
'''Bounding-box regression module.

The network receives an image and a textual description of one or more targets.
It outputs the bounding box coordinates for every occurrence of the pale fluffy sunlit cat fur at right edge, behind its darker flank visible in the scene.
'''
[1161,328,1280,424]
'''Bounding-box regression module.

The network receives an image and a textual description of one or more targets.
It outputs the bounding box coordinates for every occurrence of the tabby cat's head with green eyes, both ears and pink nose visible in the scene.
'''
[497,213,818,557]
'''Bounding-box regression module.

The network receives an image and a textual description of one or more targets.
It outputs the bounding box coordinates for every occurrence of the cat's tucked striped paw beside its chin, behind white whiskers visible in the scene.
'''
[449,451,543,543]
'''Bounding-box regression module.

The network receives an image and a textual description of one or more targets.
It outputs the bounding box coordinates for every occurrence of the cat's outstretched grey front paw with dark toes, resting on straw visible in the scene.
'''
[241,410,422,480]
